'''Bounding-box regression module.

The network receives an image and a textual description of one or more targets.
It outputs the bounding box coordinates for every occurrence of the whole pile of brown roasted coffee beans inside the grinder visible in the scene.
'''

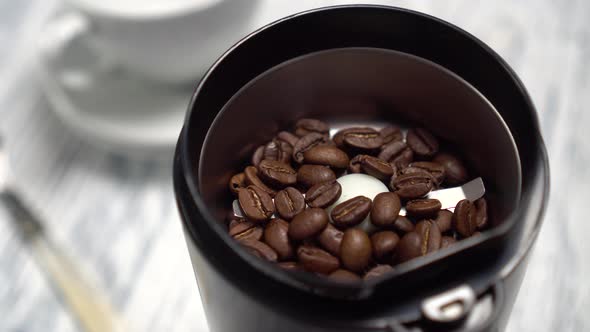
[228,119,488,282]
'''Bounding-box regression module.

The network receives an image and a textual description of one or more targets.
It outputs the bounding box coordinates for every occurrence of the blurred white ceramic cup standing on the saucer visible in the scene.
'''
[53,0,259,83]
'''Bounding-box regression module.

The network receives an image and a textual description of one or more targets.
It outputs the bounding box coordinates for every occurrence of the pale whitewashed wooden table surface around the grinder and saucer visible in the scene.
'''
[0,0,590,332]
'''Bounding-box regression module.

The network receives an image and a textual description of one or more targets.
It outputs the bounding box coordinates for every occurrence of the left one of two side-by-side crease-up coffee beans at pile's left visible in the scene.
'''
[238,186,275,222]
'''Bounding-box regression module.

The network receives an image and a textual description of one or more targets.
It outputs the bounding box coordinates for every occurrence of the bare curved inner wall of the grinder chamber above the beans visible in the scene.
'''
[198,48,521,288]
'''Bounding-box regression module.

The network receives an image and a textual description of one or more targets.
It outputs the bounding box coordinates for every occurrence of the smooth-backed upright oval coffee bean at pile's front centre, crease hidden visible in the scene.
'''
[340,228,372,272]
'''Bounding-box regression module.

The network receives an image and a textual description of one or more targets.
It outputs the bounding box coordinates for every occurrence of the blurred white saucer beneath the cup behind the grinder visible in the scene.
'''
[38,15,198,154]
